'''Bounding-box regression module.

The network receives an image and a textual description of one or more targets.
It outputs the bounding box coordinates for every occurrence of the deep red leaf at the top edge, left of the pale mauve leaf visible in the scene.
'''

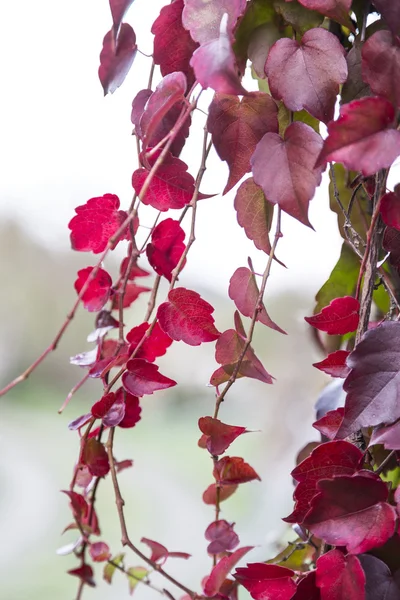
[151,0,198,88]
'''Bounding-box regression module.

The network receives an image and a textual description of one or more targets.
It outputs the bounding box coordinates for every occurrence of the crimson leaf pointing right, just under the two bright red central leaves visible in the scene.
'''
[122,358,176,397]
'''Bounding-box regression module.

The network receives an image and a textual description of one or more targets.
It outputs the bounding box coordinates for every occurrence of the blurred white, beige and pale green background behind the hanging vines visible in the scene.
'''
[0,0,346,600]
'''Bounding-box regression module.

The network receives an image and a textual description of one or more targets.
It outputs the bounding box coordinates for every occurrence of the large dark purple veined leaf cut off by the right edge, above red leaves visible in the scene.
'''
[338,321,400,438]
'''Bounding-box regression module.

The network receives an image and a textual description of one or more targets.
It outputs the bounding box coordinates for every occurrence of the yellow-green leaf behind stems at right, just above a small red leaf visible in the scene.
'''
[314,243,360,313]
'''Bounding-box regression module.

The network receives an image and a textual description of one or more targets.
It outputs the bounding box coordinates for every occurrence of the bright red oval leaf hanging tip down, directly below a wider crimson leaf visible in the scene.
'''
[146,219,185,281]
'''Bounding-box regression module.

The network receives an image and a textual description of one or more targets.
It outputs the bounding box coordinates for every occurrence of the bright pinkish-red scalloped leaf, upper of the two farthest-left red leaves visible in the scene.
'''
[68,194,129,254]
